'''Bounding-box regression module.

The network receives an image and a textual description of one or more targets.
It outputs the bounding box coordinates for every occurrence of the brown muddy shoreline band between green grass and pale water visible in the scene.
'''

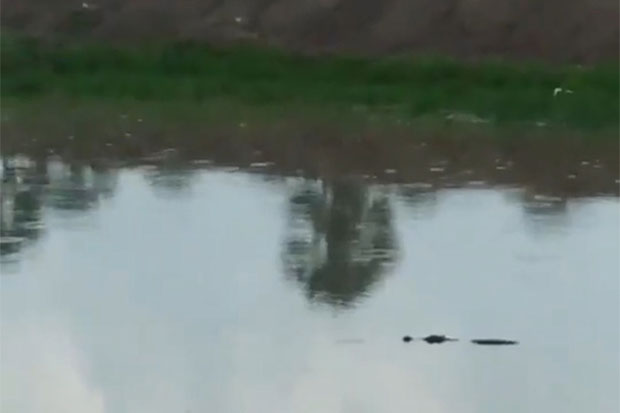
[2,122,620,198]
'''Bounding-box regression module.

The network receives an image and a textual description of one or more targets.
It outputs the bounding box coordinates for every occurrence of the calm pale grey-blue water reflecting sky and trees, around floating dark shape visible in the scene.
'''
[0,156,620,413]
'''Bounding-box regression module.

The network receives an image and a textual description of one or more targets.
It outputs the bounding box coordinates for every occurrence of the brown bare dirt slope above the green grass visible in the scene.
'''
[1,0,620,63]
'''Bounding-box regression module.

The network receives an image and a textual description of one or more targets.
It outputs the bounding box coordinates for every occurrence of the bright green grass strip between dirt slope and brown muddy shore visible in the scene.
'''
[0,35,620,130]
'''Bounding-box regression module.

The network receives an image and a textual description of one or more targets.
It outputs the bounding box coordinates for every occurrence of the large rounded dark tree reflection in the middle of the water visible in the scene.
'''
[284,180,396,306]
